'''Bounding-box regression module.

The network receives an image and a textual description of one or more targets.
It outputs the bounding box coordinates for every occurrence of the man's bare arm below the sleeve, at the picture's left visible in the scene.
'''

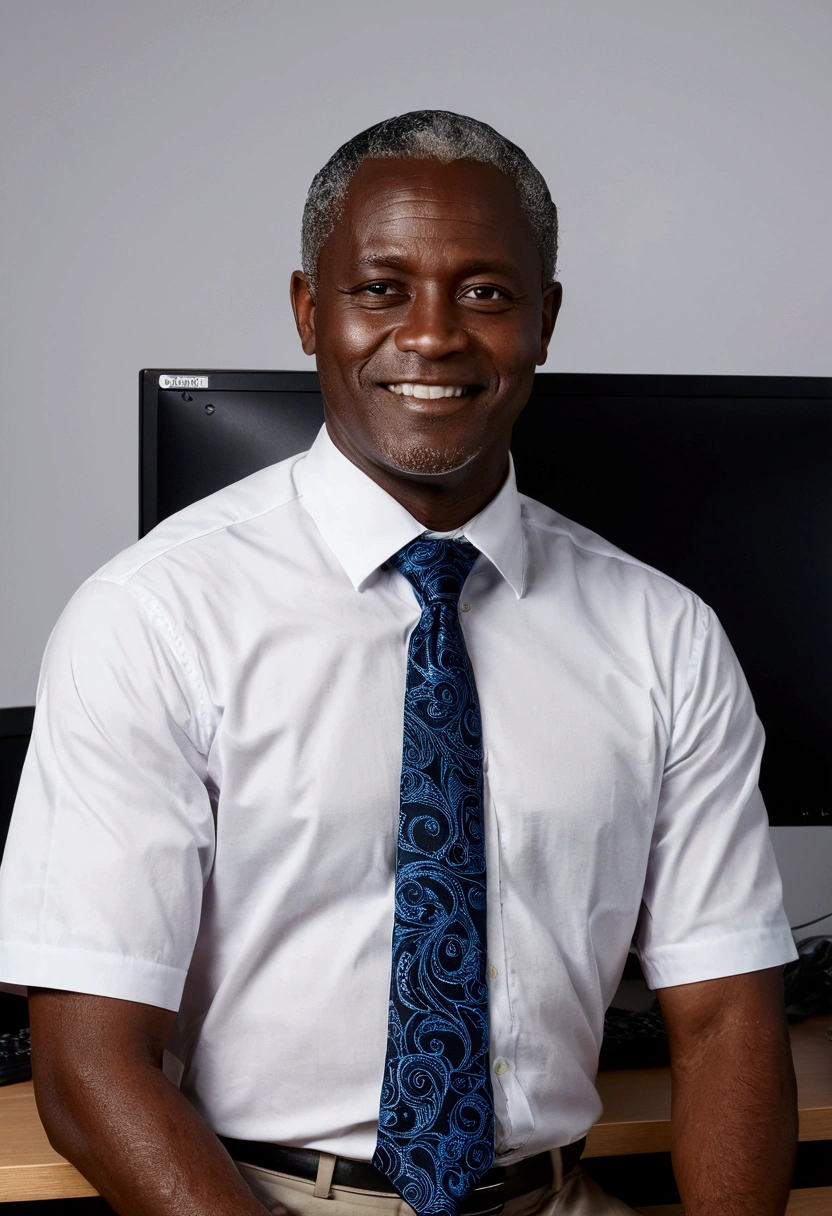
[29,989,266,1216]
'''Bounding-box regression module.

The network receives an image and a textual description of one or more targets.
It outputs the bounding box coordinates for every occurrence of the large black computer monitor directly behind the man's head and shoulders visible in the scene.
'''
[140,368,832,824]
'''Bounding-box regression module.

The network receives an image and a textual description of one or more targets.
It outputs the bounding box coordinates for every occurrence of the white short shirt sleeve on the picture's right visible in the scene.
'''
[635,602,797,989]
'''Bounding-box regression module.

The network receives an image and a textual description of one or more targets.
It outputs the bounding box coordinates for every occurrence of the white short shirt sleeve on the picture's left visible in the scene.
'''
[0,579,214,1009]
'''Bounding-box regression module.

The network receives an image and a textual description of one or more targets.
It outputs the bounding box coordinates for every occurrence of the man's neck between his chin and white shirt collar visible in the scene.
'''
[327,420,508,531]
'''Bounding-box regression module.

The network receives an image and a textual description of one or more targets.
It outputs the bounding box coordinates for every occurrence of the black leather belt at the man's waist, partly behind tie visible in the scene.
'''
[218,1136,586,1216]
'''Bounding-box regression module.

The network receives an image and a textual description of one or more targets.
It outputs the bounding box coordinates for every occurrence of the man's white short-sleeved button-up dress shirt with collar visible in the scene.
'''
[0,429,796,1162]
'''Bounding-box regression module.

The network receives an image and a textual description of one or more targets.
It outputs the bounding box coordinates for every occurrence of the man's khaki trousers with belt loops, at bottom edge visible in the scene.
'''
[236,1148,634,1216]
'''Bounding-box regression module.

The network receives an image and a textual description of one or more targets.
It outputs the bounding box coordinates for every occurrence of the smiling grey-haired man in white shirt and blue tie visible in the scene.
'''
[0,112,796,1216]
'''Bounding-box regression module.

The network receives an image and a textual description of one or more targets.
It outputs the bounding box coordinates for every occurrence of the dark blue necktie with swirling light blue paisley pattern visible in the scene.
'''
[372,536,494,1216]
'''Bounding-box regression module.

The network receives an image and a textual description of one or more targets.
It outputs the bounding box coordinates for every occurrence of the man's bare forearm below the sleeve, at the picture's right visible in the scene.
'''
[657,967,798,1216]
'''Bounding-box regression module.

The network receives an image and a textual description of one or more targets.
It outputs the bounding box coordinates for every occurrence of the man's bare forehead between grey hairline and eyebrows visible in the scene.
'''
[321,158,540,276]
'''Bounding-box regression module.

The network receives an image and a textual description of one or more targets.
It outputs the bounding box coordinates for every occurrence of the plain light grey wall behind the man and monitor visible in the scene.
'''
[0,0,832,931]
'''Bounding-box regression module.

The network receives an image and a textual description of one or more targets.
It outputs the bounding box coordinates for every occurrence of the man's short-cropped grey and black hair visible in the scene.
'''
[300,109,557,297]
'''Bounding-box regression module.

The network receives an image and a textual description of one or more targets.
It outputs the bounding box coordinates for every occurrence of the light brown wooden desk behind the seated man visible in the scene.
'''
[0,1017,832,1216]
